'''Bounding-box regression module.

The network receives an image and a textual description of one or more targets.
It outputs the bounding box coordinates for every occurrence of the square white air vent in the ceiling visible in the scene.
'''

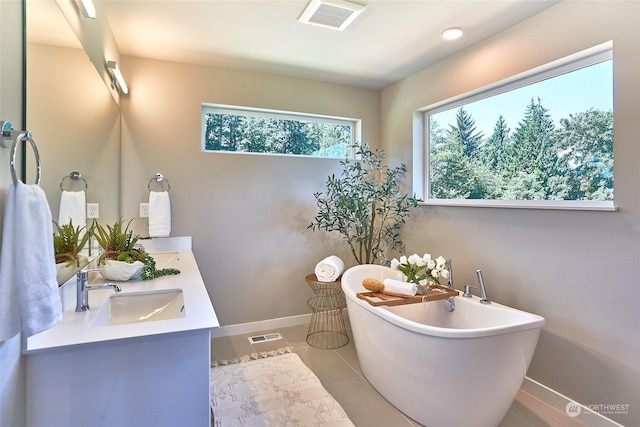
[298,0,366,31]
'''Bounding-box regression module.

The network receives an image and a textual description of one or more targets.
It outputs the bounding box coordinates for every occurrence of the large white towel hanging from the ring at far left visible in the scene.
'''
[0,181,62,341]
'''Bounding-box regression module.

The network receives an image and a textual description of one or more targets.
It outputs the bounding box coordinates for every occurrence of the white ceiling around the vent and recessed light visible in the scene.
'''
[30,0,559,89]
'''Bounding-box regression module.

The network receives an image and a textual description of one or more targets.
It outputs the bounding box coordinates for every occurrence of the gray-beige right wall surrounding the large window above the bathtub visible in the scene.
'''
[381,1,640,426]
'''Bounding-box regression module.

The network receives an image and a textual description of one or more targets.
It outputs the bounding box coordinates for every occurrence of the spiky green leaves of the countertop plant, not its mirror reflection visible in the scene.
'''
[95,219,144,264]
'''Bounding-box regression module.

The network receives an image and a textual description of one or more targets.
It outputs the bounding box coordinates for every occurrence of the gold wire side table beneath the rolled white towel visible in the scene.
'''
[305,274,349,349]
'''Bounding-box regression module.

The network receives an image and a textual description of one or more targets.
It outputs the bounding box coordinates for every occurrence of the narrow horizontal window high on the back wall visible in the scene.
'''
[202,104,360,159]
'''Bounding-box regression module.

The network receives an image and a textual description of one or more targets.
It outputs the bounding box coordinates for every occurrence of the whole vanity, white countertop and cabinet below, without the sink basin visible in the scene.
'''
[23,238,220,427]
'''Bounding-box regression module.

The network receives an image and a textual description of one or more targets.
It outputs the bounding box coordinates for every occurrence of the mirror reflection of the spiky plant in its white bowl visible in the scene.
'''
[53,219,89,284]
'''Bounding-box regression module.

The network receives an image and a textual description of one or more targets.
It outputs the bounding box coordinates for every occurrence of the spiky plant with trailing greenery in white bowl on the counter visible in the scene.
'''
[95,219,180,281]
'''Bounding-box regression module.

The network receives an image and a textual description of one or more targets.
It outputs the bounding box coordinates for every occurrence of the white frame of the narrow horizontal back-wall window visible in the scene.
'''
[200,103,362,160]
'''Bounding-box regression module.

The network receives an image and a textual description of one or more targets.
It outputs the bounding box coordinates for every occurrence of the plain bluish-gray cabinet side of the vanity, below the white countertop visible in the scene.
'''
[26,330,211,427]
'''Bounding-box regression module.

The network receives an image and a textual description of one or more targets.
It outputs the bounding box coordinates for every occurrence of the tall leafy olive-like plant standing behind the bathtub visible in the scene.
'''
[308,144,420,264]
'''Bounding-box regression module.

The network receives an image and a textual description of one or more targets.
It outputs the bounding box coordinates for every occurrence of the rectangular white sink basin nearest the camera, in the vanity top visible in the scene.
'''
[91,289,185,327]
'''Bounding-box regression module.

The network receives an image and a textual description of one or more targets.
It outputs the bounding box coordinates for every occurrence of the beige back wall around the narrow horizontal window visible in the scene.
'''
[120,57,380,326]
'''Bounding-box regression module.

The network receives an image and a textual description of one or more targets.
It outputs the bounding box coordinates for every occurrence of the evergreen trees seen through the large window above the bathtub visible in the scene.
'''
[429,99,613,200]
